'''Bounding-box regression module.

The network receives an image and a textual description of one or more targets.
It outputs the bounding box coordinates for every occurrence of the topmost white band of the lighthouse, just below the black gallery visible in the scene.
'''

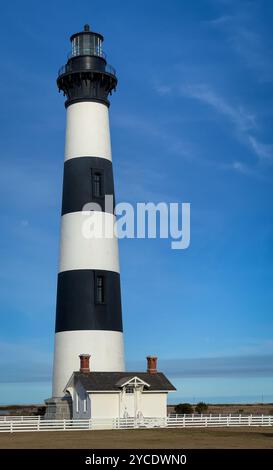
[65,101,112,161]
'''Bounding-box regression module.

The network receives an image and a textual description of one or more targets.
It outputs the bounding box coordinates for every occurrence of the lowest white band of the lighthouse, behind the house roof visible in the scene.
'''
[53,330,124,397]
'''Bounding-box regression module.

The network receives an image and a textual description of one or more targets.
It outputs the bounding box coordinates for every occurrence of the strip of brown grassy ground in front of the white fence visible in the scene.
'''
[0,427,273,449]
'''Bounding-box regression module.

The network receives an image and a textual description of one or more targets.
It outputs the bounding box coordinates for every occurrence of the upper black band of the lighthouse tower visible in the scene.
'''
[62,157,115,215]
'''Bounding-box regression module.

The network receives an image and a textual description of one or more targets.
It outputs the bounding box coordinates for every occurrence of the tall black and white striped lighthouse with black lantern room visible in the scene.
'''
[53,25,124,397]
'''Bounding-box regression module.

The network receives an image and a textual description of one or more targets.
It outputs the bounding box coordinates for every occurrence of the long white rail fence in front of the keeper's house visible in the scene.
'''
[0,415,273,432]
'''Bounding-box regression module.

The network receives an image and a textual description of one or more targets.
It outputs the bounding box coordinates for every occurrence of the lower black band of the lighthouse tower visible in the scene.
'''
[56,269,122,333]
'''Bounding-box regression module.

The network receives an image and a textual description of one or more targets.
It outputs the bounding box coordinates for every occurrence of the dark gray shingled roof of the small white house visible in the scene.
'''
[73,372,176,392]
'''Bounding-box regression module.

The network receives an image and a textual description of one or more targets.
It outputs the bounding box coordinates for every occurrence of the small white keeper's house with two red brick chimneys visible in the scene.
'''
[64,354,176,419]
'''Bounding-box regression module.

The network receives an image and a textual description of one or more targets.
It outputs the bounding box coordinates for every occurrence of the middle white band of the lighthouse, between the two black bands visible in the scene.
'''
[59,211,119,273]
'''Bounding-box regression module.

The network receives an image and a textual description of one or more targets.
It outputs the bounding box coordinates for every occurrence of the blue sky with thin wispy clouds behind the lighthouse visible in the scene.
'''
[0,0,273,403]
